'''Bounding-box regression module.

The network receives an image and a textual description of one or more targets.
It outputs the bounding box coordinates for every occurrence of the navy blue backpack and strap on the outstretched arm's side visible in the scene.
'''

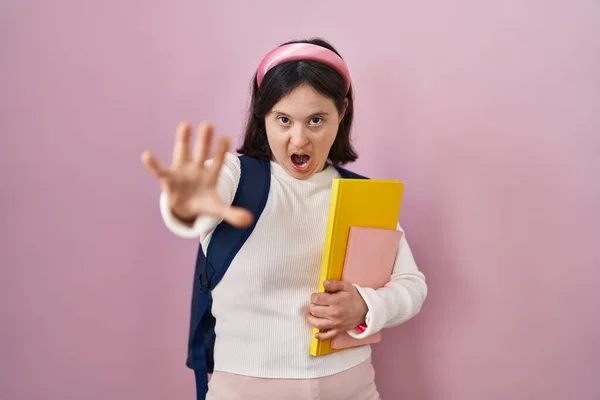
[186,155,271,400]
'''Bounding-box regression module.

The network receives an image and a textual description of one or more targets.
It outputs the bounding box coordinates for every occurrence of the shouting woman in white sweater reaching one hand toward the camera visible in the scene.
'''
[142,39,427,400]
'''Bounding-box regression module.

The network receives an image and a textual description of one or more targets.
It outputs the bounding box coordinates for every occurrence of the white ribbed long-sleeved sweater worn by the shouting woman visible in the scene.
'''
[160,154,427,378]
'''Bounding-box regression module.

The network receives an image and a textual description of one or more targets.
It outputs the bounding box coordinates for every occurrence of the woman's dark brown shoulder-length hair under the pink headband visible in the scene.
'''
[237,38,358,165]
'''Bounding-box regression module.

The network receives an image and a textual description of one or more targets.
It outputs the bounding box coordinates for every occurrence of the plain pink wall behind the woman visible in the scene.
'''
[0,0,600,400]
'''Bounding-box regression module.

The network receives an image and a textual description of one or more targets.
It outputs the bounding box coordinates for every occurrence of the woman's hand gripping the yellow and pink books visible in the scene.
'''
[306,281,368,340]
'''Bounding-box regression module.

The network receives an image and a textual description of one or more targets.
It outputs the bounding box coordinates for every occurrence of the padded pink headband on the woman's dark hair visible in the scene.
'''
[256,43,350,92]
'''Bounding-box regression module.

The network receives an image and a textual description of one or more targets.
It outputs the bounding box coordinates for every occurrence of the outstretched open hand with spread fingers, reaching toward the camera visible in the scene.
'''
[142,122,253,228]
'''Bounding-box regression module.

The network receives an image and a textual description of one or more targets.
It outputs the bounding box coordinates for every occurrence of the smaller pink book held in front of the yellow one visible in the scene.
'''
[331,226,402,349]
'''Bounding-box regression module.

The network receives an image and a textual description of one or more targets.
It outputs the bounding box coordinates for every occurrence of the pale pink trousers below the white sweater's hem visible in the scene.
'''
[206,360,381,400]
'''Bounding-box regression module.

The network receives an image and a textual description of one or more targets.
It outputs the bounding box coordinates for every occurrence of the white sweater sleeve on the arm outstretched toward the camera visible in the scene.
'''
[159,153,241,239]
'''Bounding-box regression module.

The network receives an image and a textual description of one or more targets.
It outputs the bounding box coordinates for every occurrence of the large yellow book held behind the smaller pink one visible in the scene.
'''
[310,178,404,356]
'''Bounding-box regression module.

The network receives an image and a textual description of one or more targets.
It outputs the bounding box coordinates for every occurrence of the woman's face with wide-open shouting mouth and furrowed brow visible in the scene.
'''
[265,85,347,179]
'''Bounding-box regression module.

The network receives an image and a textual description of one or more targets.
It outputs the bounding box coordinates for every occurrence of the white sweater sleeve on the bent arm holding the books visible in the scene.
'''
[348,226,427,339]
